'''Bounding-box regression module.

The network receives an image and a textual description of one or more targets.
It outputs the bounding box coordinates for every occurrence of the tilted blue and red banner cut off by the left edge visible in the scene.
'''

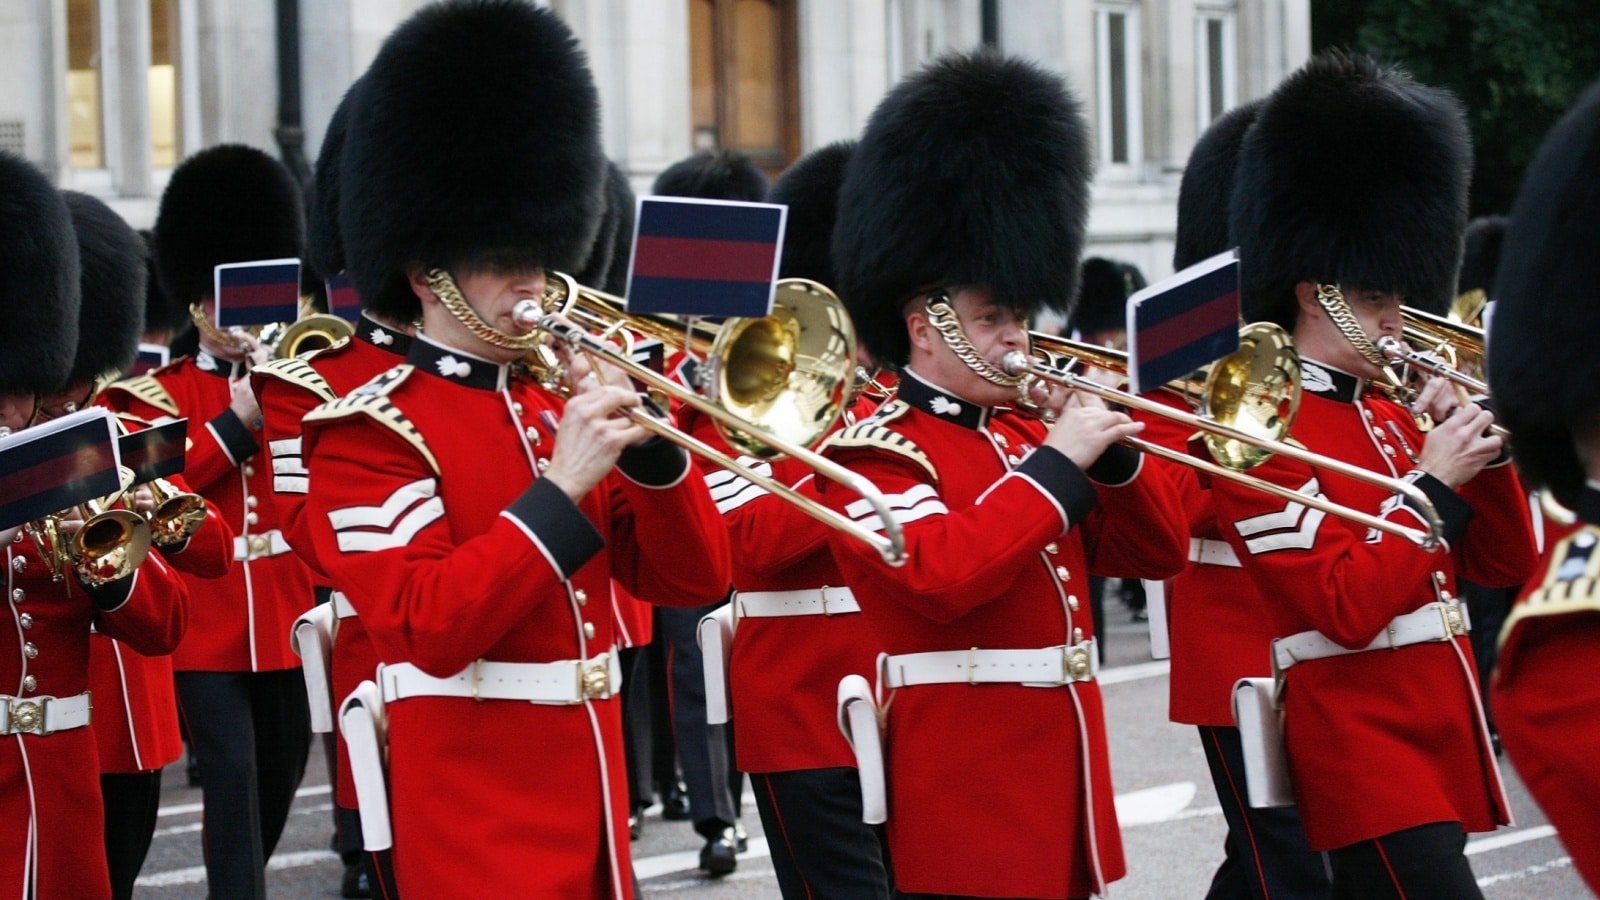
[0,407,122,528]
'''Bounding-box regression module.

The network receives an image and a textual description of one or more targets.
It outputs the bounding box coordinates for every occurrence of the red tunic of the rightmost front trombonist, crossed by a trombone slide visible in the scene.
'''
[1213,360,1534,850]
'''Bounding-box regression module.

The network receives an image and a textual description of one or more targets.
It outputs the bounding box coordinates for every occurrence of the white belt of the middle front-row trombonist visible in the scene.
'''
[882,637,1099,689]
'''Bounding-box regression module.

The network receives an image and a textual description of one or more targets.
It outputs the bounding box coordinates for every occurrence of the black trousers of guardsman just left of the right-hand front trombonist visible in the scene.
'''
[1200,725,1330,900]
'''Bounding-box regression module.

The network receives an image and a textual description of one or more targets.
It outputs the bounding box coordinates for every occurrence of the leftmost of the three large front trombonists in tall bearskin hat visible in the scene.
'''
[302,0,728,897]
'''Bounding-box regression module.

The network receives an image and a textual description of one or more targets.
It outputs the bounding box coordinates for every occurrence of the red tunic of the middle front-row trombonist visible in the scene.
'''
[821,372,1187,897]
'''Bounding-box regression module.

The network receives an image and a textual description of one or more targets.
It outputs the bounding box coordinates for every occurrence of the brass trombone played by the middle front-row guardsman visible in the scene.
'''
[1005,322,1445,551]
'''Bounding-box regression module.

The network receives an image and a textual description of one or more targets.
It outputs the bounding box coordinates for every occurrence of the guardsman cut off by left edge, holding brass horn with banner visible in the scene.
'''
[0,152,187,900]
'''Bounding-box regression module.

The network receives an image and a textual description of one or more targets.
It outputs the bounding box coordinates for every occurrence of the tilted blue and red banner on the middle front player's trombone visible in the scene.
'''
[1128,250,1238,394]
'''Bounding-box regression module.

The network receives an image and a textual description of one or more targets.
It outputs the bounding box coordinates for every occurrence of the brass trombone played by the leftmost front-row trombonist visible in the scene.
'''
[517,272,906,565]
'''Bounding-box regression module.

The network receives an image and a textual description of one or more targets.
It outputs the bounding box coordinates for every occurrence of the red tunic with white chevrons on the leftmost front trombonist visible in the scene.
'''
[304,338,728,897]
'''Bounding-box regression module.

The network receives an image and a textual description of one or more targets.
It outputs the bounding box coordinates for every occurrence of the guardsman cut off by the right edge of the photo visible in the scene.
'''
[1490,76,1600,890]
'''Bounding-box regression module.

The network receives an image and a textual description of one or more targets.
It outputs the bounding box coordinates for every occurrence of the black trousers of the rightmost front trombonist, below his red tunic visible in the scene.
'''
[1328,822,1483,900]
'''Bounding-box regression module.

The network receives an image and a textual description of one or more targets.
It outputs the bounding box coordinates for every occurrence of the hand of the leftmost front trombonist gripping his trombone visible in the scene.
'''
[544,373,650,503]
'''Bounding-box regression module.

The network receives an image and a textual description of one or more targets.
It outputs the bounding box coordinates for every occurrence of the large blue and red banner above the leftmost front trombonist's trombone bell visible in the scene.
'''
[627,197,789,317]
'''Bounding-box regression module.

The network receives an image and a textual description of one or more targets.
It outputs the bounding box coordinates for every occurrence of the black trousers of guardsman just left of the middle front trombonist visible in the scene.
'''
[750,767,890,900]
